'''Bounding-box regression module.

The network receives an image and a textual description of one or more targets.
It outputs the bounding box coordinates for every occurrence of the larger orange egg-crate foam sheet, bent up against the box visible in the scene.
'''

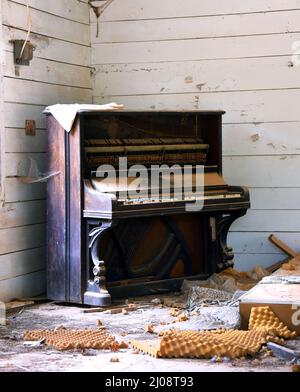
[131,307,297,358]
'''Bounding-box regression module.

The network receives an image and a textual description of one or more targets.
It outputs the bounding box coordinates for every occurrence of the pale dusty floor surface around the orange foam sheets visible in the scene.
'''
[0,303,300,372]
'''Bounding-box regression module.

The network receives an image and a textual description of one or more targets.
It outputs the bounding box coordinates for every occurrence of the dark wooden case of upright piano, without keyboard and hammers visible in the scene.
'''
[47,111,250,306]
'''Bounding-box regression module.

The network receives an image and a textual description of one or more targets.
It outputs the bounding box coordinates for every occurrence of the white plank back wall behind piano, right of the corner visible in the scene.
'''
[91,0,300,270]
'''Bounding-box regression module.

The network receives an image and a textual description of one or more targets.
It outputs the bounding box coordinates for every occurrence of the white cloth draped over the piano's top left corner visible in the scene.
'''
[44,102,124,132]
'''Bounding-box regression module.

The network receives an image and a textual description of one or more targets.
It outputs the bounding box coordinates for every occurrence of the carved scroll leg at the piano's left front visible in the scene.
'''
[84,222,112,306]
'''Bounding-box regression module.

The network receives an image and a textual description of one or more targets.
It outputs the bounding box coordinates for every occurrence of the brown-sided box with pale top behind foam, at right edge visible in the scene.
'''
[240,283,300,335]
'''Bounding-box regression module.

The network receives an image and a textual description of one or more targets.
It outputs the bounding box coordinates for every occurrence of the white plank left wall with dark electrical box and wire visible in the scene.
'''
[0,0,92,301]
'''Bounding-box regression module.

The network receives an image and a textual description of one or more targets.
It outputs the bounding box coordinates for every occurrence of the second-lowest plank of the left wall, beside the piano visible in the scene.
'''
[0,247,46,282]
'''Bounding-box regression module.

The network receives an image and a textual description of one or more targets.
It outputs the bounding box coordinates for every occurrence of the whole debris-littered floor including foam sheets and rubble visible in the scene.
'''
[0,260,300,371]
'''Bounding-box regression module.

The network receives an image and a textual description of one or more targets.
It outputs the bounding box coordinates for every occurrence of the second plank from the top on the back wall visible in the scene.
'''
[91,7,300,44]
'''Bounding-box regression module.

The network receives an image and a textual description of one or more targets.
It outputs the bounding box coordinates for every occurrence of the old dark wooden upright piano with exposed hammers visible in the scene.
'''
[47,111,250,306]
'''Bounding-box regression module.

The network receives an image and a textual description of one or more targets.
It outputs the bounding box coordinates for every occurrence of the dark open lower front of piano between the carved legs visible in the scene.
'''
[100,215,205,287]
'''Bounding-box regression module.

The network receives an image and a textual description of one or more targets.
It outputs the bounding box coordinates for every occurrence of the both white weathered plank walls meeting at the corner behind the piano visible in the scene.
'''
[0,0,300,301]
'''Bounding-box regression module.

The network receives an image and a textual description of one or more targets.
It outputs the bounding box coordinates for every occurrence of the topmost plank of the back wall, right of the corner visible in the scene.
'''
[91,0,300,21]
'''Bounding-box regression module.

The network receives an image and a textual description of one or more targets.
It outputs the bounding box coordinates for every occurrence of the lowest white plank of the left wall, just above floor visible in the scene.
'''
[0,270,46,302]
